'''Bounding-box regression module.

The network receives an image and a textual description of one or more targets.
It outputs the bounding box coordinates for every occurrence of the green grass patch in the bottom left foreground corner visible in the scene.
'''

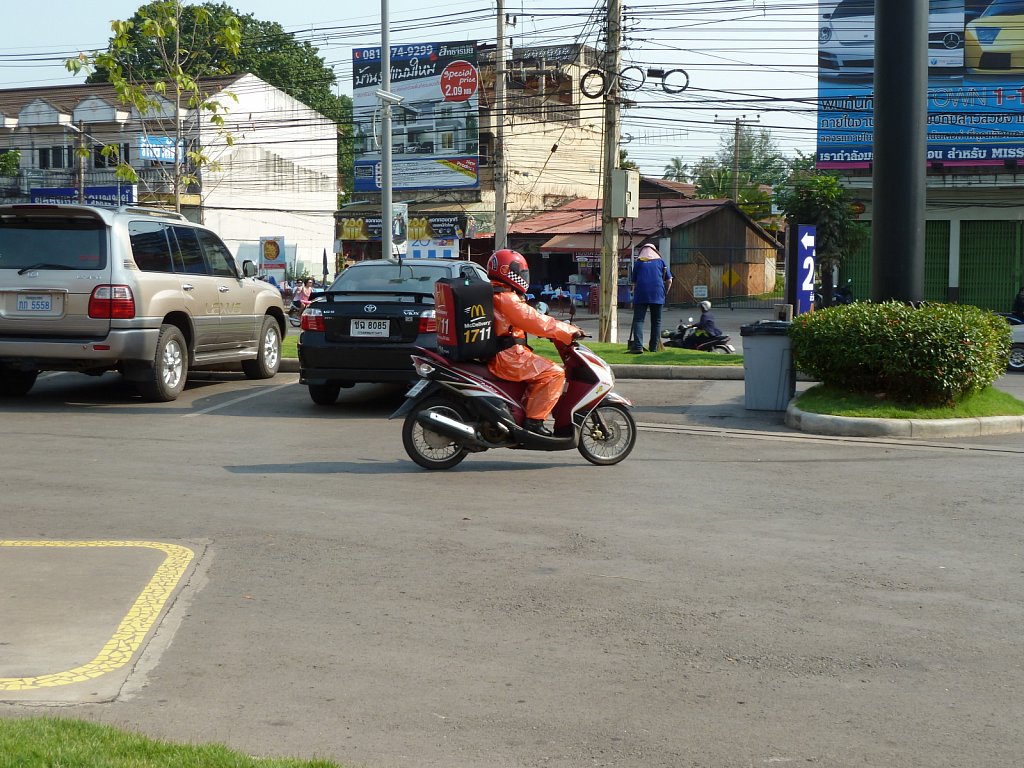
[0,717,339,768]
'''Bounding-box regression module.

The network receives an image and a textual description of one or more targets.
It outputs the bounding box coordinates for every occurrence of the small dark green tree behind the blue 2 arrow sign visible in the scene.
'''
[775,171,867,306]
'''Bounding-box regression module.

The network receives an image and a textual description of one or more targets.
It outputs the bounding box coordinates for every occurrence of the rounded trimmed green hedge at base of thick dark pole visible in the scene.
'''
[790,301,1011,406]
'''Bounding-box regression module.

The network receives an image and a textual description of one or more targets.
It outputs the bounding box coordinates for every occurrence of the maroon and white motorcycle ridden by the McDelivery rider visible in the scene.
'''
[390,341,636,469]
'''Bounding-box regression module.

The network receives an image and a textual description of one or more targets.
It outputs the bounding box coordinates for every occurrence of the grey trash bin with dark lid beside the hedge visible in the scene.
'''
[739,321,797,411]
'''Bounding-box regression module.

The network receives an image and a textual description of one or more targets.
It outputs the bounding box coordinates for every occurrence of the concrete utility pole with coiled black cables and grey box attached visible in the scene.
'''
[598,0,623,344]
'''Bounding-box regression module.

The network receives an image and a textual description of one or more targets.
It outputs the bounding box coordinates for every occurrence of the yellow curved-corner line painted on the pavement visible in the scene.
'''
[0,539,196,690]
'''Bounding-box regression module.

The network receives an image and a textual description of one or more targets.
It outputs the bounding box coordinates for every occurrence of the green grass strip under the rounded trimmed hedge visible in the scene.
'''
[797,384,1024,419]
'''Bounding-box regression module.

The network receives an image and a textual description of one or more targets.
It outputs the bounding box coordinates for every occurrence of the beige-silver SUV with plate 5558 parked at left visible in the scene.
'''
[0,205,285,401]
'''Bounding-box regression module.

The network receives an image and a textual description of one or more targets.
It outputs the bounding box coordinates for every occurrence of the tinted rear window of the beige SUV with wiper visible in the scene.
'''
[0,216,106,270]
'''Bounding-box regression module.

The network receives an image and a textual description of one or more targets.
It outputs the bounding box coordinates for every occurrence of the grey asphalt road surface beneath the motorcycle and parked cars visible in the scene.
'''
[0,375,1024,768]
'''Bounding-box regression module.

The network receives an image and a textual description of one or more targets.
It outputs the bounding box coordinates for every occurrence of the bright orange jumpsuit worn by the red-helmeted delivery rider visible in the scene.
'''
[487,284,579,421]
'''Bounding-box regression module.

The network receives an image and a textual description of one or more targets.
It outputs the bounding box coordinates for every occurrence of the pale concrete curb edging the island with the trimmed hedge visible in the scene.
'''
[785,400,1024,439]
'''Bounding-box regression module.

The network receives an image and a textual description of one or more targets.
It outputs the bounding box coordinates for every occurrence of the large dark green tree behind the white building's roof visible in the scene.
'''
[77,0,353,202]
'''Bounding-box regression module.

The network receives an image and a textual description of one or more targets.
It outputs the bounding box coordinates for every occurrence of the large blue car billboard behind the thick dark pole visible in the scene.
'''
[816,0,1024,169]
